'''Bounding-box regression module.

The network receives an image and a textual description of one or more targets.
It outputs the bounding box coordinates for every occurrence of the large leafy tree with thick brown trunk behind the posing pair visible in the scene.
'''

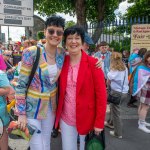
[34,0,122,43]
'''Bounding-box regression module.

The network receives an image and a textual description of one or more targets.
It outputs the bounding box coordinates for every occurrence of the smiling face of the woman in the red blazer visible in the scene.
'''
[66,33,82,55]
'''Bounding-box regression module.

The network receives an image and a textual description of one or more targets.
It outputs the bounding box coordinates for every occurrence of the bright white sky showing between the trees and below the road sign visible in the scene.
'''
[1,0,132,41]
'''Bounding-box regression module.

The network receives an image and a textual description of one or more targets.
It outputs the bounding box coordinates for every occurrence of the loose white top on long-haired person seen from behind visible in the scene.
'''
[107,68,129,93]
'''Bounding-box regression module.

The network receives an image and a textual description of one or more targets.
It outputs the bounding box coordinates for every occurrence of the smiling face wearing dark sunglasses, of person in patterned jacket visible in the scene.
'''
[44,26,63,46]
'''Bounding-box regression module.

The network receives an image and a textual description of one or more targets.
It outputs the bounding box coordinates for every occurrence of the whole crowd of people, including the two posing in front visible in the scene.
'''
[0,15,150,150]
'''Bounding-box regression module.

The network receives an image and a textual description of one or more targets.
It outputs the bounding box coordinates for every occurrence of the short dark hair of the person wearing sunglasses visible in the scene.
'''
[45,15,65,29]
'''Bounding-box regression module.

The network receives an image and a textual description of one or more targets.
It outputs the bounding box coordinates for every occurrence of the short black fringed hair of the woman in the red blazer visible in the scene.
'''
[64,25,85,44]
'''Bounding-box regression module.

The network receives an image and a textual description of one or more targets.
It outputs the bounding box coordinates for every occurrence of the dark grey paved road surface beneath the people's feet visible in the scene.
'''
[9,119,150,150]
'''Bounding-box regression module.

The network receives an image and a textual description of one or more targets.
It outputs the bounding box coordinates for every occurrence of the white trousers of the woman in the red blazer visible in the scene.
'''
[60,119,85,150]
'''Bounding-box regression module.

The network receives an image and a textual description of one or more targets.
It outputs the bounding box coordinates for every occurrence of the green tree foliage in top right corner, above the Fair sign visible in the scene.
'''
[125,0,150,18]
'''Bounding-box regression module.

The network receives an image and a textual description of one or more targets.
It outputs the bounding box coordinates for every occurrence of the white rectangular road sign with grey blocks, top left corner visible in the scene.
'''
[0,0,33,26]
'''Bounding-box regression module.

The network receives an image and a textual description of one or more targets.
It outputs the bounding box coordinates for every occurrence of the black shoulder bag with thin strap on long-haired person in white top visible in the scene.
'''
[107,71,126,105]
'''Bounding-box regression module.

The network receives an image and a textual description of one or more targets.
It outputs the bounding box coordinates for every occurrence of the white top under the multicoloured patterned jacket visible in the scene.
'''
[48,64,57,84]
